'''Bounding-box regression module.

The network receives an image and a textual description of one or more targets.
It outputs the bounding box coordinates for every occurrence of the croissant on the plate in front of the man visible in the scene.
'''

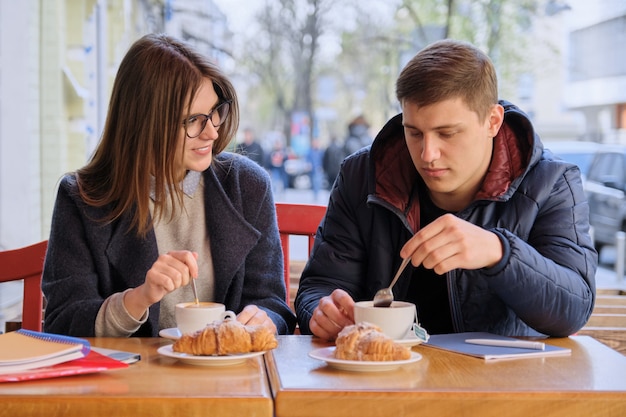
[335,322,411,361]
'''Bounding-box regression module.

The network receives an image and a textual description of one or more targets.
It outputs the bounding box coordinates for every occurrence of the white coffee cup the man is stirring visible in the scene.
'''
[354,301,416,340]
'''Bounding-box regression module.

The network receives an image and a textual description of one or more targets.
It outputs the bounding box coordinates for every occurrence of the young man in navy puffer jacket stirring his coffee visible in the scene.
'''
[295,40,597,339]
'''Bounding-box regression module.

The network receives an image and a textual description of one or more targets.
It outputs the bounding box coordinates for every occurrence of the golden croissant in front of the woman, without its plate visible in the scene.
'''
[172,319,278,356]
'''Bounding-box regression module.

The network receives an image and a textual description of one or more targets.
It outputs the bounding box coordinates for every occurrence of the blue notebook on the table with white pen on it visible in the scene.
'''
[423,332,572,361]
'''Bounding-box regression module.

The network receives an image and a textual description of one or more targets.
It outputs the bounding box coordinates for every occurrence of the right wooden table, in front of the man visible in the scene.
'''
[266,336,626,417]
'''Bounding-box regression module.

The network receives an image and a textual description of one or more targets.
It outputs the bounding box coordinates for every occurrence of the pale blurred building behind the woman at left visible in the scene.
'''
[0,0,227,331]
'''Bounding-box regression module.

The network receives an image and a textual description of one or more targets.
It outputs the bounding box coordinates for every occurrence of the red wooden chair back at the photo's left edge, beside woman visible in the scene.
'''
[0,240,48,331]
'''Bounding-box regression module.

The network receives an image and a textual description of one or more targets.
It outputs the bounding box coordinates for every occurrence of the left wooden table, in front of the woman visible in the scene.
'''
[0,338,273,417]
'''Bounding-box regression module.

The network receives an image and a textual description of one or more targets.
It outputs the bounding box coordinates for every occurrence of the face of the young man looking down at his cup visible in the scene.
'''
[402,98,504,211]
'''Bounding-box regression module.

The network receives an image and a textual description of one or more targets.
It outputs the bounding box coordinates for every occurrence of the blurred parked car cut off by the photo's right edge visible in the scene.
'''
[585,145,626,251]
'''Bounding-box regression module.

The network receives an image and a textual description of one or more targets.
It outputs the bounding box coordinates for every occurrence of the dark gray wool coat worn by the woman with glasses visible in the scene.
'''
[42,152,295,337]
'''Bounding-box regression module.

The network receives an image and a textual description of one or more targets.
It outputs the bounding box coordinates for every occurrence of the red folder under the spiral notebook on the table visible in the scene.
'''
[0,350,128,382]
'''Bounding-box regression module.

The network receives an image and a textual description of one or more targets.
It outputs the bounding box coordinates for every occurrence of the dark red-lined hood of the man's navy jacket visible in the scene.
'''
[369,101,543,230]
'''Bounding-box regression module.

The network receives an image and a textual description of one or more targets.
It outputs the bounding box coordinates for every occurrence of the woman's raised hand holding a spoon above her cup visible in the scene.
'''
[124,250,198,319]
